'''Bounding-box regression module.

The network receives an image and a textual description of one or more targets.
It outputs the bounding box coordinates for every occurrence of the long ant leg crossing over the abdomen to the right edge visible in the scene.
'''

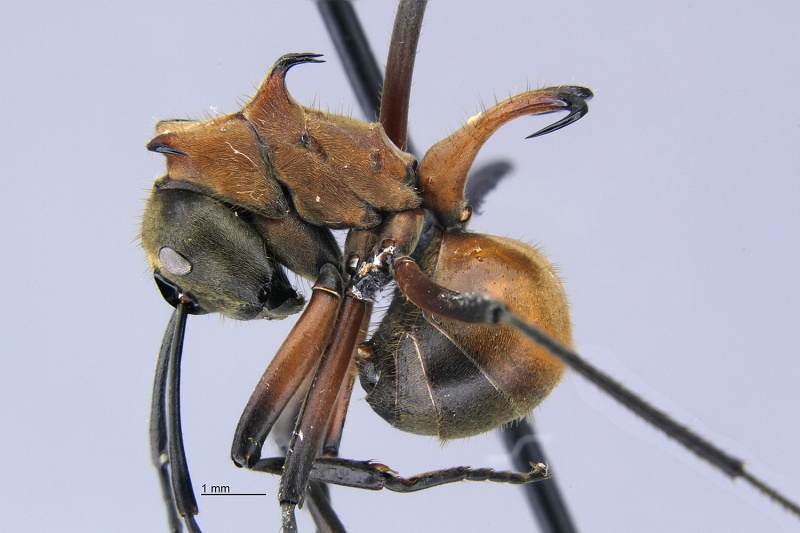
[393,257,800,516]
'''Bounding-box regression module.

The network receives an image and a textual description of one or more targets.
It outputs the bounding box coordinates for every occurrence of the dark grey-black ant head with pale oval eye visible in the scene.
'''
[142,179,304,320]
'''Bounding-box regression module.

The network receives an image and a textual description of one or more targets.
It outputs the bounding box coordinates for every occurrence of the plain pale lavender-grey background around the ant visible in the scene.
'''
[0,2,800,532]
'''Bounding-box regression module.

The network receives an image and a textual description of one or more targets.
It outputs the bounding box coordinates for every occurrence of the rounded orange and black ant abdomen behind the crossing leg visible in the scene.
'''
[358,230,572,439]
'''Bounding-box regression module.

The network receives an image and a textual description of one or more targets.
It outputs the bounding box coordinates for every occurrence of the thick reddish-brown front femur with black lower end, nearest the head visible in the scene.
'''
[231,264,342,466]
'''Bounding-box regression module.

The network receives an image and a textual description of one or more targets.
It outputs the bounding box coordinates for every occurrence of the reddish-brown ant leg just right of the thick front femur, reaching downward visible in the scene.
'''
[278,296,366,531]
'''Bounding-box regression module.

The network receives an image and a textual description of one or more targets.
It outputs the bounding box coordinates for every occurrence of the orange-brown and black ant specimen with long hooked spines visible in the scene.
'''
[142,2,800,531]
